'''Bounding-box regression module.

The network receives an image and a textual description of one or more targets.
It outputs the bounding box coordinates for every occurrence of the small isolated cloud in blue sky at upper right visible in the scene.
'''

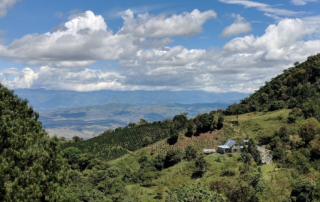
[221,15,252,37]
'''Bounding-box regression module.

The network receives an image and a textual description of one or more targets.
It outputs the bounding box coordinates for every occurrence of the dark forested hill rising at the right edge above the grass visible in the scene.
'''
[225,54,320,119]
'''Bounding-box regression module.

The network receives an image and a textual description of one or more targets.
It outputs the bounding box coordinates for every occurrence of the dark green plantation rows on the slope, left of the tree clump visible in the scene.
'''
[63,122,170,160]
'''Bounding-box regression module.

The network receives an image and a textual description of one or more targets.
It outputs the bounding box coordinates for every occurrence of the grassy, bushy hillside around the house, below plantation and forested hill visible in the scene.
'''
[65,109,320,202]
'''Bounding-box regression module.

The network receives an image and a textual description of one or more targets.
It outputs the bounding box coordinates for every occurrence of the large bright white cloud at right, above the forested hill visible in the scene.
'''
[224,19,319,61]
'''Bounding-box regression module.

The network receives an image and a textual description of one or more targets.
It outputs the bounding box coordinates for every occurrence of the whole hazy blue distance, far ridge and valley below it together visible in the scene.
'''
[14,89,247,138]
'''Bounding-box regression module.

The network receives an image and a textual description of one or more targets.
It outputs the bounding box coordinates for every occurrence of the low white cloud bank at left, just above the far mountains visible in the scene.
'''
[1,66,129,91]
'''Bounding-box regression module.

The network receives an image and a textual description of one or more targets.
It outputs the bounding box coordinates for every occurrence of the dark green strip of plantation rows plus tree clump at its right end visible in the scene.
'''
[63,111,221,160]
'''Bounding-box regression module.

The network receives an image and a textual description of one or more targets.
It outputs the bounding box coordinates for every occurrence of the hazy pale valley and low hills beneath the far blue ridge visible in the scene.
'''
[40,103,228,138]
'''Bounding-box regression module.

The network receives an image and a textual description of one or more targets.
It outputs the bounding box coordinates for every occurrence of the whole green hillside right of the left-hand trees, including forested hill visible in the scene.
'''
[58,55,320,202]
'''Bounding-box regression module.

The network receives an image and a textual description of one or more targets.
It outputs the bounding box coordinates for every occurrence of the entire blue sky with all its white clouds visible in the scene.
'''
[0,0,320,93]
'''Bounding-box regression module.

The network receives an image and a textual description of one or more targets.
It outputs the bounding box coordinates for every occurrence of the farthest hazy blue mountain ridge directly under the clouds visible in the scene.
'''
[14,89,248,111]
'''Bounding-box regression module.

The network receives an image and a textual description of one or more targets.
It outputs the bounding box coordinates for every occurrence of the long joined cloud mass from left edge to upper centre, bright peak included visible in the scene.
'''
[0,10,216,68]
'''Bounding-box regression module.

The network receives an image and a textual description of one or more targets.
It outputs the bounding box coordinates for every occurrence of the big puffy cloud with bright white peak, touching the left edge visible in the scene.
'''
[0,11,135,67]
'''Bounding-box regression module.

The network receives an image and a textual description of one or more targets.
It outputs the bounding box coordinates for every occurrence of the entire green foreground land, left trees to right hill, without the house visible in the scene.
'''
[0,55,320,202]
